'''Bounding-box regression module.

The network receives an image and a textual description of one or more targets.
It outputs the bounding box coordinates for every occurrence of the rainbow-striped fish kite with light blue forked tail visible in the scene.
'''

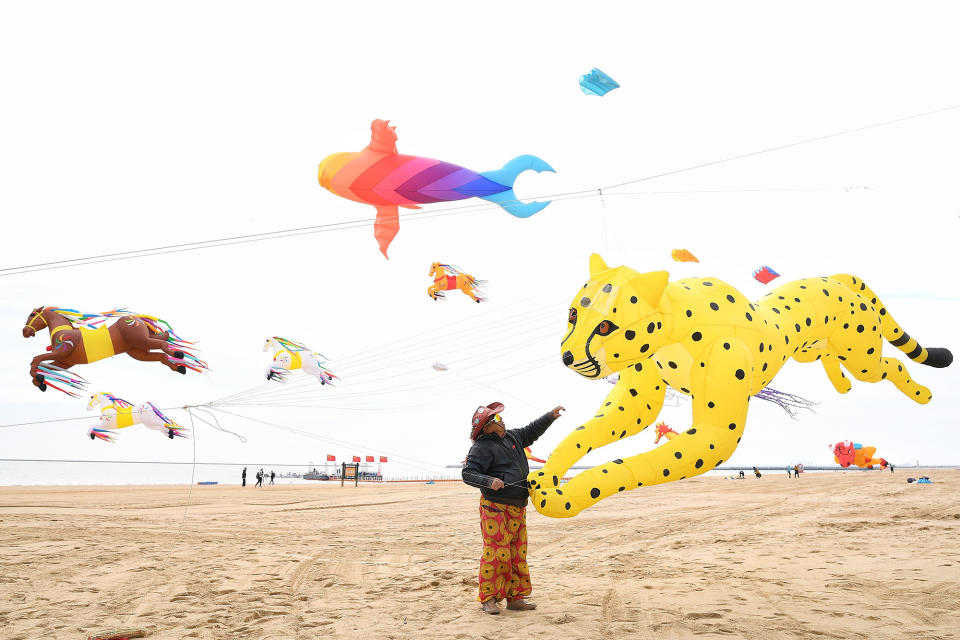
[318,120,553,257]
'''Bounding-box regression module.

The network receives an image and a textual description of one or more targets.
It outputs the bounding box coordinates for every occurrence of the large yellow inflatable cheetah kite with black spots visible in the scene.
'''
[528,254,953,517]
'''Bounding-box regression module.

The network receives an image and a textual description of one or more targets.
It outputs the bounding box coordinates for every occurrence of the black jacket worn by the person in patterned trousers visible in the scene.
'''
[462,413,555,507]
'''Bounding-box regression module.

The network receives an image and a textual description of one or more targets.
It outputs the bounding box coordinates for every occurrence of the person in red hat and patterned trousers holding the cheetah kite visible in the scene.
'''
[462,402,565,615]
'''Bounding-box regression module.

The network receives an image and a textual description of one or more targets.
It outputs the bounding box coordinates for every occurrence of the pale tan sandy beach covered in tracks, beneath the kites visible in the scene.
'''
[0,469,960,640]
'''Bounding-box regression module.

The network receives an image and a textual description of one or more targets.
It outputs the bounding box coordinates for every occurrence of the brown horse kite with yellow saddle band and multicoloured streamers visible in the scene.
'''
[23,307,207,396]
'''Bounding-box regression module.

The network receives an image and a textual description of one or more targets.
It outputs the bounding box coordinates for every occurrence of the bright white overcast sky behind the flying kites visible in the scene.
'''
[0,2,960,473]
